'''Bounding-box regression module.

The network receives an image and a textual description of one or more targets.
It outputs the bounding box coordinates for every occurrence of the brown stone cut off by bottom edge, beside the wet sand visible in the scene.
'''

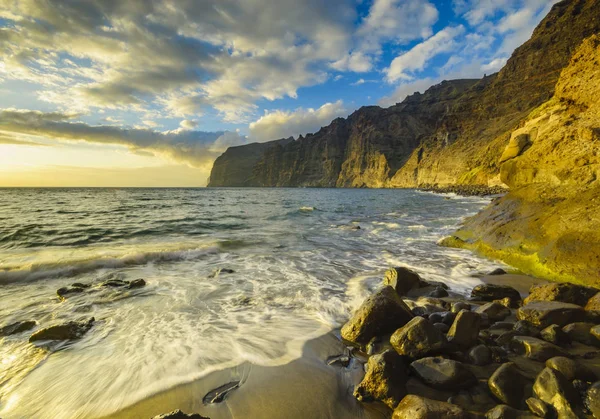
[392,394,471,419]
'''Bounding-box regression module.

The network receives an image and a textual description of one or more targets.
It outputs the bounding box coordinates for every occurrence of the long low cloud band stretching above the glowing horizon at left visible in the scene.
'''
[0,109,246,168]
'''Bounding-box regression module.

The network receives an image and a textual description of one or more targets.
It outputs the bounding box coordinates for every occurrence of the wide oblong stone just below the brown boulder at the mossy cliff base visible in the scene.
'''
[517,301,585,328]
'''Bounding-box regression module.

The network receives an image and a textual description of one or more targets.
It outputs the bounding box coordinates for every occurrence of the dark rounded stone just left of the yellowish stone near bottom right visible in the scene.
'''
[488,362,531,409]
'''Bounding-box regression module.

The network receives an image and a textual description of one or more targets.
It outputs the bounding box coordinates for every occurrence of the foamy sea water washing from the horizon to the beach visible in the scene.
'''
[0,189,498,419]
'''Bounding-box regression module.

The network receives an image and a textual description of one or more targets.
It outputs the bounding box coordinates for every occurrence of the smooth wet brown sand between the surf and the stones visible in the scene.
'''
[108,332,391,419]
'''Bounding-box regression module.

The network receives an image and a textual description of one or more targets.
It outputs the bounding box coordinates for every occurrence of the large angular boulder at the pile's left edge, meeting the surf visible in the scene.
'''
[341,287,413,345]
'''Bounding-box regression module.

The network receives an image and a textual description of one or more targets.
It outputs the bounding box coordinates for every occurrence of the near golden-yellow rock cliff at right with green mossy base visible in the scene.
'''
[445,35,600,286]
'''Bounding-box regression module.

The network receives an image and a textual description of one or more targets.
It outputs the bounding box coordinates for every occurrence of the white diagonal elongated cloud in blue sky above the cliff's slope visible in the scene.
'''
[385,25,465,82]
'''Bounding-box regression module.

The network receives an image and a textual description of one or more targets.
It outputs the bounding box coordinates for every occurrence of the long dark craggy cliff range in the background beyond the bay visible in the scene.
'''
[209,0,600,187]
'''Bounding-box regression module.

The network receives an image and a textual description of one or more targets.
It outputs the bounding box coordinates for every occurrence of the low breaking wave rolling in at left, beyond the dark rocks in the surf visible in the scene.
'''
[0,243,221,284]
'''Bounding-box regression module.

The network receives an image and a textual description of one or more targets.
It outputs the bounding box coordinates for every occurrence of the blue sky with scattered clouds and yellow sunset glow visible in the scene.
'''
[0,0,557,187]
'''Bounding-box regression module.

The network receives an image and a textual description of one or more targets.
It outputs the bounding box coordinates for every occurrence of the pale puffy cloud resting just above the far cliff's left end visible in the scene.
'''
[249,100,348,142]
